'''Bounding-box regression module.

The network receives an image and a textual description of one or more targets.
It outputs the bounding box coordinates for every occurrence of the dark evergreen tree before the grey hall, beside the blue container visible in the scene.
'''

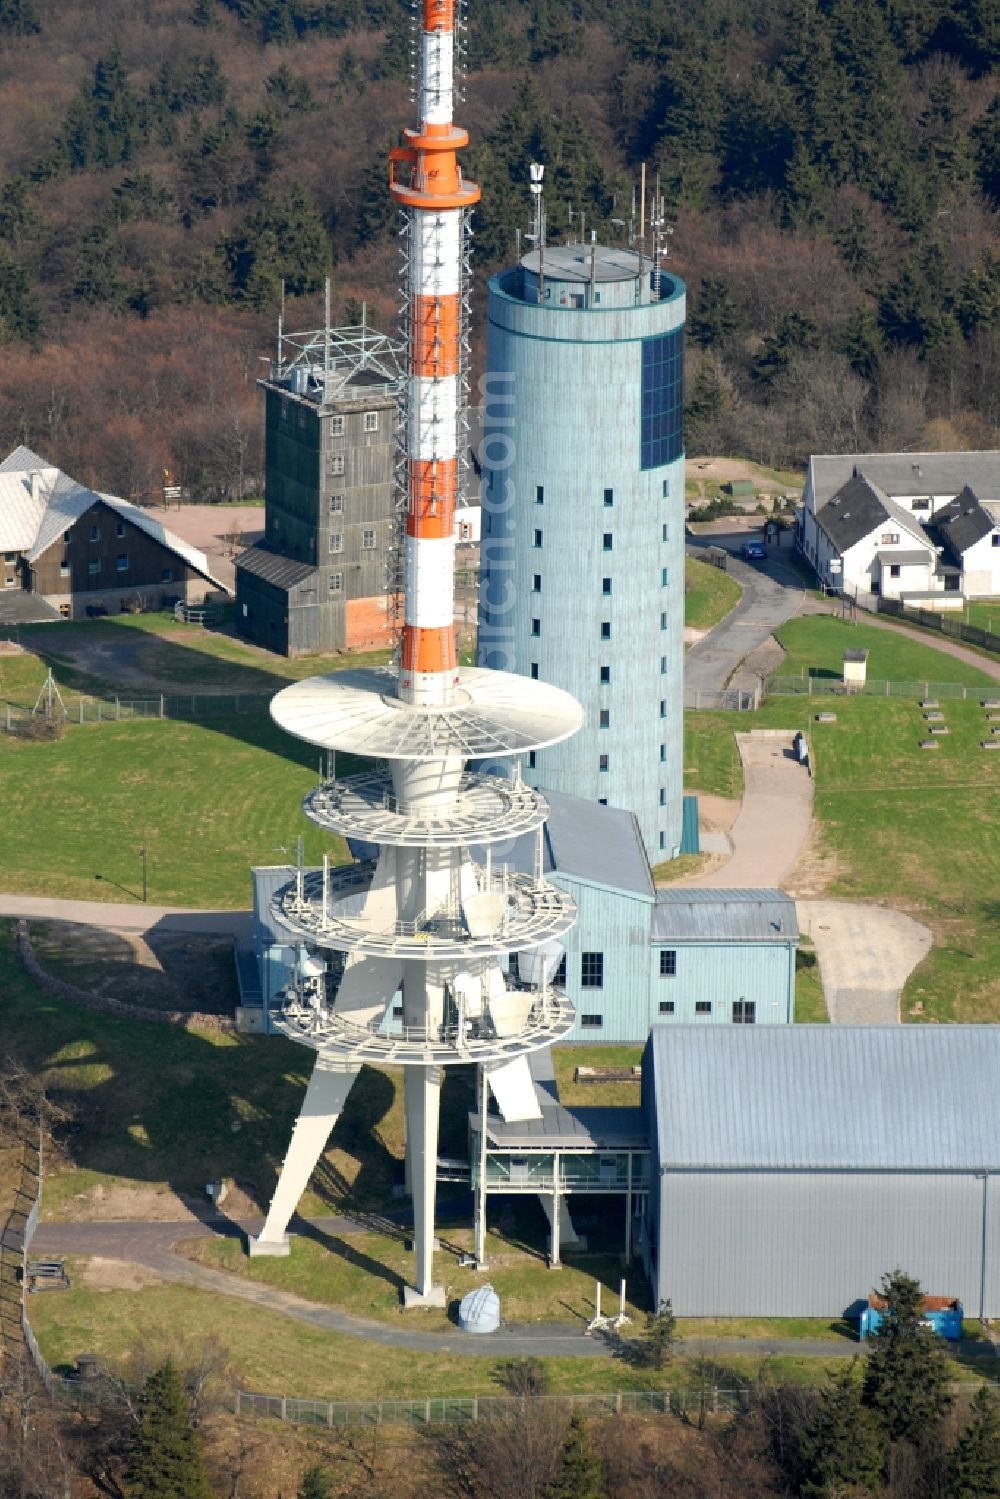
[862,1270,952,1442]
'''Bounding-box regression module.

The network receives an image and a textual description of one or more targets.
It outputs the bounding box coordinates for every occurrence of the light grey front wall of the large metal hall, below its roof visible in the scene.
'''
[657,1171,1000,1318]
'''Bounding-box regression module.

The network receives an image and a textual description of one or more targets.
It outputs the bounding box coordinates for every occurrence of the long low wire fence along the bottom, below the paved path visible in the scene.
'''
[235,1385,750,1427]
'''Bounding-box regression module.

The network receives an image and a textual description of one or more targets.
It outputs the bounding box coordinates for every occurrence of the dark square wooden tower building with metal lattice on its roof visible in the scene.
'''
[235,327,402,655]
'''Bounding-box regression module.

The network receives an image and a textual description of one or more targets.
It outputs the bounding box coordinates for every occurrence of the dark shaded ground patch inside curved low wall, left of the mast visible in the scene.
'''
[31,922,238,1015]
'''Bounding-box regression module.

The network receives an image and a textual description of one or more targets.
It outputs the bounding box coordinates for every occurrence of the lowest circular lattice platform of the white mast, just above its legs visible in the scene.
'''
[271,988,576,1067]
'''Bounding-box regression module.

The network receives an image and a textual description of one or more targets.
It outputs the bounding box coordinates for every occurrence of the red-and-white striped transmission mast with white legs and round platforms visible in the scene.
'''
[249,0,583,1306]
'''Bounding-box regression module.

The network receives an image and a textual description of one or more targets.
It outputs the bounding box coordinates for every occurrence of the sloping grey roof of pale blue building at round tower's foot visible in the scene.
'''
[485,787,655,899]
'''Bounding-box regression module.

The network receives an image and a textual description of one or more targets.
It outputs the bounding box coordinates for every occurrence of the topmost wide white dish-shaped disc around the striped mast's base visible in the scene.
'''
[271,667,583,761]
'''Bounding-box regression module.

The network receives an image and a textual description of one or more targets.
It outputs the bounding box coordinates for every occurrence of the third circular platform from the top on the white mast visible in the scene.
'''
[271,863,576,964]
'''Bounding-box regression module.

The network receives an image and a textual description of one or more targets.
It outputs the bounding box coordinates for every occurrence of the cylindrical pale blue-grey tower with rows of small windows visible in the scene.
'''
[478,244,685,863]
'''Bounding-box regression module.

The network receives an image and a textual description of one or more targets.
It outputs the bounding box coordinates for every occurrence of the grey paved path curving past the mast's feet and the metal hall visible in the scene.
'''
[31,1217,859,1358]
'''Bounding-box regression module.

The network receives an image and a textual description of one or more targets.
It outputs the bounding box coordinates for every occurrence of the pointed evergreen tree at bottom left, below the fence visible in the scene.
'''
[126,1358,211,1499]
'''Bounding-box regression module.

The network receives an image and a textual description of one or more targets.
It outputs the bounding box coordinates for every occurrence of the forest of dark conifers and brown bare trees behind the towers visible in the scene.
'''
[0,0,1000,498]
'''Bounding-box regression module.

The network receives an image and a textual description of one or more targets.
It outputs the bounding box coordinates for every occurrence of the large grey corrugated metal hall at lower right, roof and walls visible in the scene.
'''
[642,1025,1000,1318]
